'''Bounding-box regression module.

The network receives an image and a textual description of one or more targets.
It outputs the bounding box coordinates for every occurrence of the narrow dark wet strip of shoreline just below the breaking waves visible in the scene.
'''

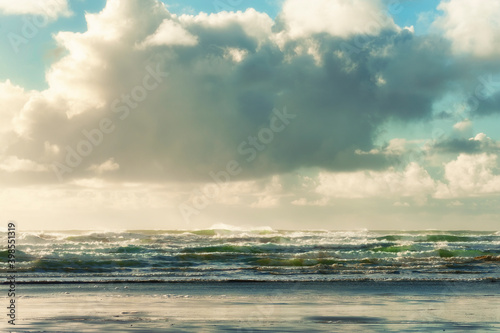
[13,281,500,297]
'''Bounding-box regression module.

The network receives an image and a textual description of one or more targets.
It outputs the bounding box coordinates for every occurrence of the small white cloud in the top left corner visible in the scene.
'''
[0,0,71,19]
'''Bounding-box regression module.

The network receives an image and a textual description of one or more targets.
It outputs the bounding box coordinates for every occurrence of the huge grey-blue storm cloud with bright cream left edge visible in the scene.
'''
[0,0,500,187]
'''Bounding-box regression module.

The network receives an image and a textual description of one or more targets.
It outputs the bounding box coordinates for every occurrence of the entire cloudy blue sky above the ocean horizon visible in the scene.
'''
[0,0,500,230]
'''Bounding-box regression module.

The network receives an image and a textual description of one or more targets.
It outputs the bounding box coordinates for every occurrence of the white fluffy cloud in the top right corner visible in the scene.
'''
[434,0,500,57]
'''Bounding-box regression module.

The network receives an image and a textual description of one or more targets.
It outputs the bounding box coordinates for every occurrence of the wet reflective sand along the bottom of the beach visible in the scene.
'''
[2,281,500,332]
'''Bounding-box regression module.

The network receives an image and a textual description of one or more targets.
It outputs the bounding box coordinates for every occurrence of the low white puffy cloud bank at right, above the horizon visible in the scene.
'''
[306,153,500,201]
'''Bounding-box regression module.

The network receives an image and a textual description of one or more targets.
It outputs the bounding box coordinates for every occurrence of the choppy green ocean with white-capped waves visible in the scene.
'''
[4,226,500,283]
